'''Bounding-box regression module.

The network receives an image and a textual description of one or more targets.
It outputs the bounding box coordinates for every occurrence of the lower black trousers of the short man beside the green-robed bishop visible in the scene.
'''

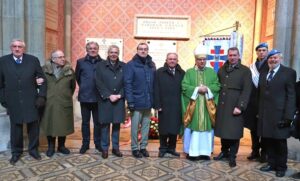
[159,134,177,152]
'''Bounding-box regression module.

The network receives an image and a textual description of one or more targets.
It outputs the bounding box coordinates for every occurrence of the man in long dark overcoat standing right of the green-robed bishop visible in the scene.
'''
[214,47,252,167]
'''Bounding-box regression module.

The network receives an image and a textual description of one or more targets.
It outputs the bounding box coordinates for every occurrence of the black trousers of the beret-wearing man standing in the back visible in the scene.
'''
[250,130,266,155]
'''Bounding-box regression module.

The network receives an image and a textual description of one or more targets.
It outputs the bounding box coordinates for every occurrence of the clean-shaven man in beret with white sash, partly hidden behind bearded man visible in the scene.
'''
[243,43,269,163]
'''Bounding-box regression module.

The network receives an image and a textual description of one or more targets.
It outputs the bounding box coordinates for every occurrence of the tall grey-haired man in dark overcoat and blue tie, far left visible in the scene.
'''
[0,39,47,165]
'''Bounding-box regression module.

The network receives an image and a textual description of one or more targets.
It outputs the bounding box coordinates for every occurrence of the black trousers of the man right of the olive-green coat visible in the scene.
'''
[80,102,101,148]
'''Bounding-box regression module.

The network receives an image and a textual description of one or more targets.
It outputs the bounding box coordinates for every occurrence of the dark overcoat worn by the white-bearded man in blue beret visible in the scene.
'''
[257,65,296,139]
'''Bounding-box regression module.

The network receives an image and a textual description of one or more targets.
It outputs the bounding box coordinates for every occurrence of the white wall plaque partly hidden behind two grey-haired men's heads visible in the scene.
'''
[85,38,123,61]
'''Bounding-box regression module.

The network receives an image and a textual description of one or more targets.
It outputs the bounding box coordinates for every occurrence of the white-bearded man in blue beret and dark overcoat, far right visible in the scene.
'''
[257,50,296,177]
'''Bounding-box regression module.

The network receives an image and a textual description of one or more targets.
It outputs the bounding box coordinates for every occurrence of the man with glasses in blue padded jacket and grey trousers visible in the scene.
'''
[124,43,155,158]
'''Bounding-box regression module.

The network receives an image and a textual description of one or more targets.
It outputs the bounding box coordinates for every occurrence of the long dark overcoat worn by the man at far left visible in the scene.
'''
[0,54,47,123]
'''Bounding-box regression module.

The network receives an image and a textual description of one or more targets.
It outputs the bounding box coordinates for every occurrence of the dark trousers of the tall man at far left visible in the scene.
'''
[10,121,39,155]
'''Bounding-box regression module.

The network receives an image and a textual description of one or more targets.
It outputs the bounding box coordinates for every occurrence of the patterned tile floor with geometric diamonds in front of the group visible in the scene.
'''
[0,149,300,181]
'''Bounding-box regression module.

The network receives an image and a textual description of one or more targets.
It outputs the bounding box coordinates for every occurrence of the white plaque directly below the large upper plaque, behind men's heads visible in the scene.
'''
[147,40,177,69]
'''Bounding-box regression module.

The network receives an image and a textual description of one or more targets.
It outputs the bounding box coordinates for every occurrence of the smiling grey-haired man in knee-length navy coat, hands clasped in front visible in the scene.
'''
[95,45,125,159]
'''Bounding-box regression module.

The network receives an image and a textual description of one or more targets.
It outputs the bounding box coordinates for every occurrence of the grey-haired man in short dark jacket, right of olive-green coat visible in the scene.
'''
[75,41,102,154]
